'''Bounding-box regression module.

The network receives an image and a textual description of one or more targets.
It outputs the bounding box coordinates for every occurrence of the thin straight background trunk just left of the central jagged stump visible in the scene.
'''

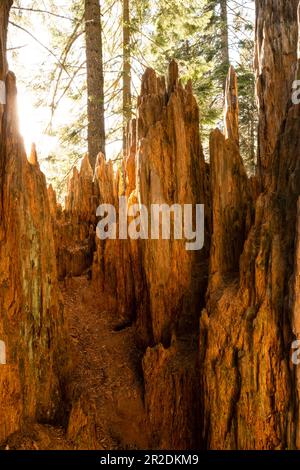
[123,0,132,151]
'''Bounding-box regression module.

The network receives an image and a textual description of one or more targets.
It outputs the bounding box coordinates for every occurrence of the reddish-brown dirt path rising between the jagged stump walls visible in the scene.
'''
[61,276,147,449]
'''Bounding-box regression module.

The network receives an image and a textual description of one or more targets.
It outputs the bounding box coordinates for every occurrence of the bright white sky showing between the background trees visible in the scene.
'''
[8,0,254,197]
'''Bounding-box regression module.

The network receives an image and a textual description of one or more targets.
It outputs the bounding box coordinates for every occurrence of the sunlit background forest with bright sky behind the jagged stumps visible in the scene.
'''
[8,0,257,198]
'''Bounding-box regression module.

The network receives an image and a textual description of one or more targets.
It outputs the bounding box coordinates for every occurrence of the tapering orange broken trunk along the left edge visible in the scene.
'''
[0,1,69,442]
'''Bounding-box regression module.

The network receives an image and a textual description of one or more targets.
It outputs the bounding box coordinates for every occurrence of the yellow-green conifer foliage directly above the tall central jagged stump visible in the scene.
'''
[149,0,222,141]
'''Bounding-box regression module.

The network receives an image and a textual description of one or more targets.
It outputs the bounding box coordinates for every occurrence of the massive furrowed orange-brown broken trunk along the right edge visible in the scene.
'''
[200,0,300,449]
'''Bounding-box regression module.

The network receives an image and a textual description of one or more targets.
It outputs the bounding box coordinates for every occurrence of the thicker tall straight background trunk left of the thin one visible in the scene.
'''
[85,0,105,169]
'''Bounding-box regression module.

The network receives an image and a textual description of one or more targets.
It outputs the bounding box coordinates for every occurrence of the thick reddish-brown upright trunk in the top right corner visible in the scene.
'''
[255,0,299,189]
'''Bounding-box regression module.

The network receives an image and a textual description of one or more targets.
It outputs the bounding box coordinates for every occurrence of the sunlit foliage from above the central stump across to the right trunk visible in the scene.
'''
[146,0,257,165]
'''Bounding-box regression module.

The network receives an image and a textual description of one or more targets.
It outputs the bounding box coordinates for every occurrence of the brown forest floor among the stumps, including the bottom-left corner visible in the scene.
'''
[2,276,147,450]
